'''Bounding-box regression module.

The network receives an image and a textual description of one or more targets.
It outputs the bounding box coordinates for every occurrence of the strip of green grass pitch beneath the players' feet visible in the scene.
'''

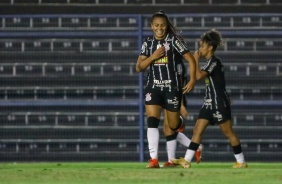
[0,162,282,184]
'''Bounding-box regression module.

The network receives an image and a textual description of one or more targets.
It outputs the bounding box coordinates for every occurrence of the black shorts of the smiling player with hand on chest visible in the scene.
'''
[145,88,182,112]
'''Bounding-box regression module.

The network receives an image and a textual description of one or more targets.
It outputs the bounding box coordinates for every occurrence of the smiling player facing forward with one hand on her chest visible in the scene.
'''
[136,11,196,168]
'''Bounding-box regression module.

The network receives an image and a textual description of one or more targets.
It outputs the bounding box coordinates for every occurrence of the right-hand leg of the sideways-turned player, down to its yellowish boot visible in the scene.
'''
[219,120,248,168]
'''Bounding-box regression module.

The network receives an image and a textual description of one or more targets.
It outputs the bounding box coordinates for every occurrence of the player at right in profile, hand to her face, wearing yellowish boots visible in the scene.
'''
[172,29,247,168]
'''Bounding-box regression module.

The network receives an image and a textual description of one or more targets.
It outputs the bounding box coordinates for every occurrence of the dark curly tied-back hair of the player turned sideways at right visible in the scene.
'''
[201,29,223,51]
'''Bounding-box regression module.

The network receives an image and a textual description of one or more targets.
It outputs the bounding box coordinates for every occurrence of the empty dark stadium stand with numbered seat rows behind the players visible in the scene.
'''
[0,3,282,161]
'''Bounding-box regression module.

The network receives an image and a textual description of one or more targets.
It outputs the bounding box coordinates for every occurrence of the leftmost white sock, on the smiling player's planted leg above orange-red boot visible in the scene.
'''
[147,128,160,159]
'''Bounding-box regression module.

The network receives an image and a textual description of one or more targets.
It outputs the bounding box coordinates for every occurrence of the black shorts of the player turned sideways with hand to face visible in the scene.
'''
[198,98,231,125]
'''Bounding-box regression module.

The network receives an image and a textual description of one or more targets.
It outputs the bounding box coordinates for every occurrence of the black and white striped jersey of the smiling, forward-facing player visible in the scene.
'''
[140,33,189,91]
